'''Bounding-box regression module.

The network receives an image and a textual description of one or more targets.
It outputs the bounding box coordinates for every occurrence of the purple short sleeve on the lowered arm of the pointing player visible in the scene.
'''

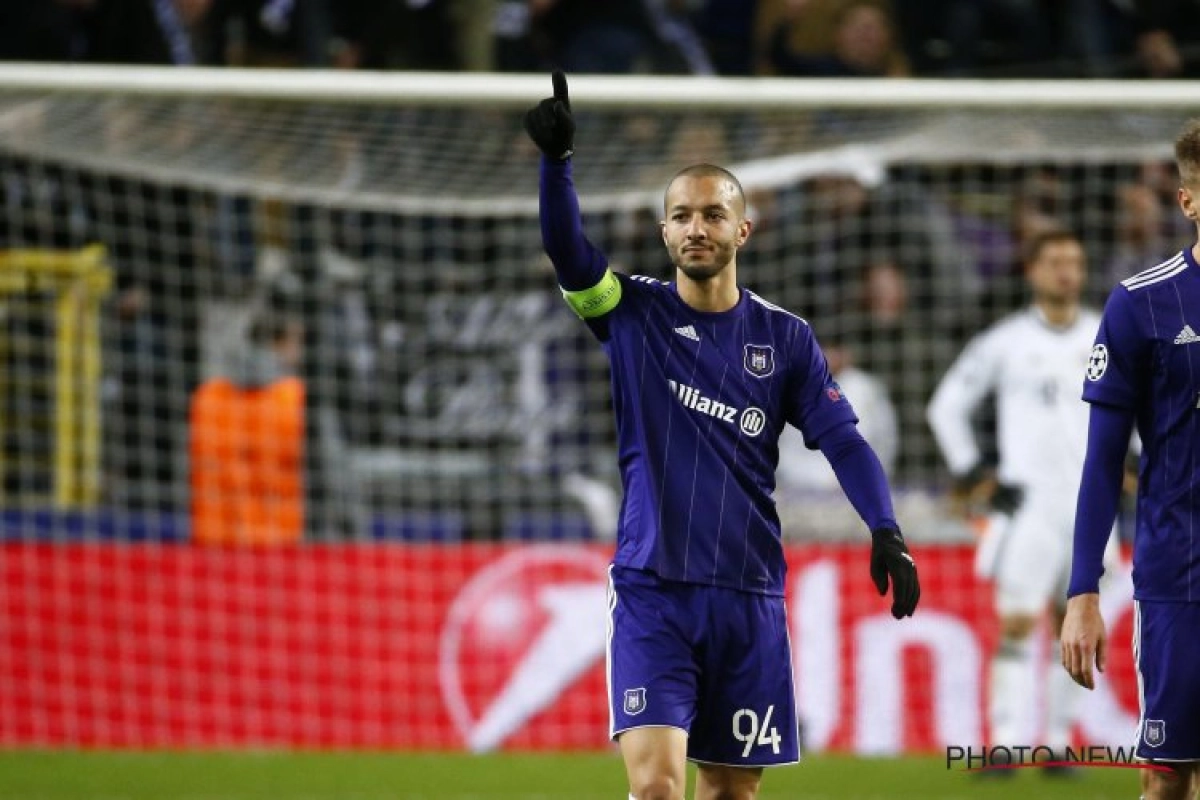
[786,325,858,450]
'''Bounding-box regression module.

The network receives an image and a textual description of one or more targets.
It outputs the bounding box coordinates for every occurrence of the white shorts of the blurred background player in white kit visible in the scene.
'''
[976,492,1118,616]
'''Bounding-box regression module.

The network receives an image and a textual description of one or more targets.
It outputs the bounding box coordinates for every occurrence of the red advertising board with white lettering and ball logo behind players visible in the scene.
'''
[0,542,1136,753]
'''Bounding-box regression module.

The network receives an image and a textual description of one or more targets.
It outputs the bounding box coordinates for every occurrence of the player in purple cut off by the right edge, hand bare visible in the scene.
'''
[1062,120,1200,800]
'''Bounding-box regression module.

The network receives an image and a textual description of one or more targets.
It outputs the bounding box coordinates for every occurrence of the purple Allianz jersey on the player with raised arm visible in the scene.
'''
[590,276,858,595]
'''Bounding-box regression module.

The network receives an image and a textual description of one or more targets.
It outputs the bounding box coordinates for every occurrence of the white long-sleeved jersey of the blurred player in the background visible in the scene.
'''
[926,307,1100,494]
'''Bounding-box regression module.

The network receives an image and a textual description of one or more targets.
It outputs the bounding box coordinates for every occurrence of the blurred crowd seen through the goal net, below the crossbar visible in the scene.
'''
[0,142,1188,537]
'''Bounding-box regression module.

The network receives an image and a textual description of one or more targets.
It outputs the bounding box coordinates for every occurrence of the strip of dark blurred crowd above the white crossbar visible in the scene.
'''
[7,0,1200,78]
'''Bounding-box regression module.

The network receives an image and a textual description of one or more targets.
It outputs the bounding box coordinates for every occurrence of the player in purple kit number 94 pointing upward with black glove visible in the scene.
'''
[524,72,920,800]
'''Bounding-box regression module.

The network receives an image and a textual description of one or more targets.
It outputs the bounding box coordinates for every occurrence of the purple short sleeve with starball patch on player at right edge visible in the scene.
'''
[1084,285,1150,409]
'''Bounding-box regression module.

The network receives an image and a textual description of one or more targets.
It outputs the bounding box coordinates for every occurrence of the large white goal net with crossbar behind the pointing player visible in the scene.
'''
[0,65,1193,752]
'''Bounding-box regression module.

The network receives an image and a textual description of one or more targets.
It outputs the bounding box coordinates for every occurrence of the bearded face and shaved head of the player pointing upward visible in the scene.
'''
[662,175,750,281]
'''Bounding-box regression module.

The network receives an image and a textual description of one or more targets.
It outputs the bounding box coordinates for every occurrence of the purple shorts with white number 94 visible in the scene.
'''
[607,566,799,766]
